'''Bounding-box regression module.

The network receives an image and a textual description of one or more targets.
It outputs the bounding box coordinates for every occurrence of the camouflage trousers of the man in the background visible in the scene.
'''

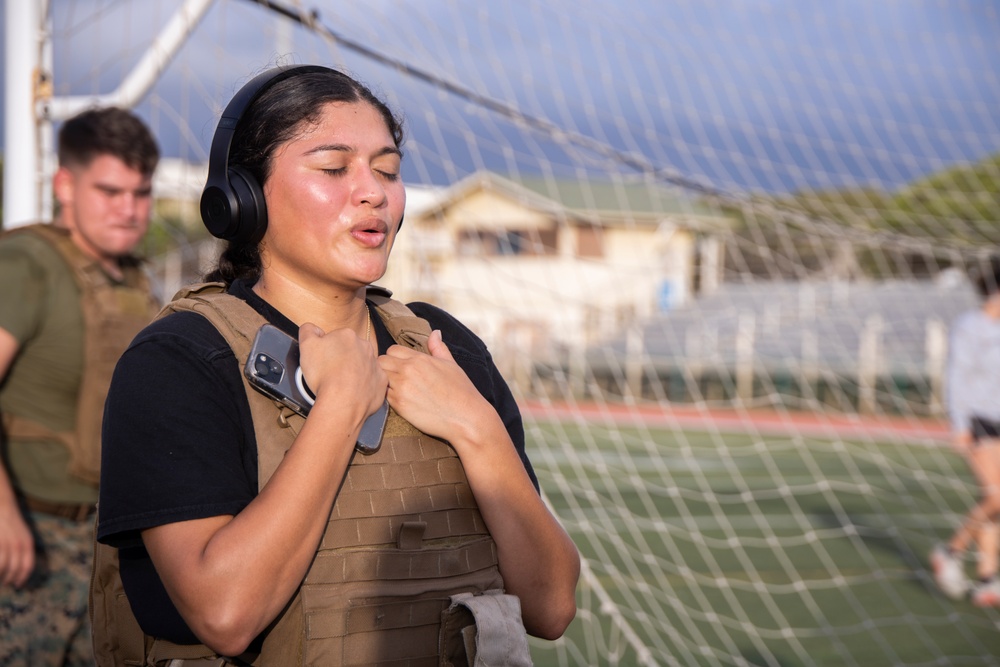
[0,512,94,667]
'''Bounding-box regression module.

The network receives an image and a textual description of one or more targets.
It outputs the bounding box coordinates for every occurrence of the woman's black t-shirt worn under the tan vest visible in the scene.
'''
[97,281,538,643]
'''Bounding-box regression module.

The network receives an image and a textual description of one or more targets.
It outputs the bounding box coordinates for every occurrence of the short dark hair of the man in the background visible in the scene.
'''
[59,107,160,176]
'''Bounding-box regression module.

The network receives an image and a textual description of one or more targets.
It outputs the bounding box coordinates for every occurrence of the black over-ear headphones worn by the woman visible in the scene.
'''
[201,65,331,244]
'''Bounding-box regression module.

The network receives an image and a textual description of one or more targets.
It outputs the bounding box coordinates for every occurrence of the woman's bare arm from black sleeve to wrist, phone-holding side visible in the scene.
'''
[143,401,361,655]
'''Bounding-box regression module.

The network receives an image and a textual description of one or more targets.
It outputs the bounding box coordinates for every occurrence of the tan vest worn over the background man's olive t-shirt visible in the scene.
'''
[3,223,159,485]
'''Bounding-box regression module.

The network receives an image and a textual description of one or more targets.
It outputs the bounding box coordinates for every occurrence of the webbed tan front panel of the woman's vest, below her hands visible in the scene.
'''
[261,411,503,667]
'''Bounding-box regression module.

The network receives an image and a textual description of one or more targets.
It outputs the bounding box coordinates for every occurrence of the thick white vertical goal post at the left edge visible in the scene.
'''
[3,0,42,229]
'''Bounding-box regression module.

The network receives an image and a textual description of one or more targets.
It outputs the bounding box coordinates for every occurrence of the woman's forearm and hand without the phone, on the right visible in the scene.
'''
[379,330,580,639]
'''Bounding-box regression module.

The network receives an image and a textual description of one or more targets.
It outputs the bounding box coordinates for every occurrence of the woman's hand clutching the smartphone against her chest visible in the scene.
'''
[299,322,389,423]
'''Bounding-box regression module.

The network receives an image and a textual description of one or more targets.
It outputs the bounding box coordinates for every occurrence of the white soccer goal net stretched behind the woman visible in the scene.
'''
[41,0,1000,667]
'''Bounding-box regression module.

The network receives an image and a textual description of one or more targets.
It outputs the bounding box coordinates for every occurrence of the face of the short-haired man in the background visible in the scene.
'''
[55,155,153,265]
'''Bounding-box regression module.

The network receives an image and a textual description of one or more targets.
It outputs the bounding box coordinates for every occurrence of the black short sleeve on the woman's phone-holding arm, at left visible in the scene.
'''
[98,313,257,546]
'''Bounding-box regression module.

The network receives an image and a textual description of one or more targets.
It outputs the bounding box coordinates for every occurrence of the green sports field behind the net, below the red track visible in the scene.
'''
[526,420,1000,667]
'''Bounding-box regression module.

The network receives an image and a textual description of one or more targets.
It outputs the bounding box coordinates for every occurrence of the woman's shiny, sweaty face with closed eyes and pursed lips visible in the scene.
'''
[262,102,406,290]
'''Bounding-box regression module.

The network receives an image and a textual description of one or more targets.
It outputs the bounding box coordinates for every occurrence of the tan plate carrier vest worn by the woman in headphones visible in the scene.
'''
[90,283,530,667]
